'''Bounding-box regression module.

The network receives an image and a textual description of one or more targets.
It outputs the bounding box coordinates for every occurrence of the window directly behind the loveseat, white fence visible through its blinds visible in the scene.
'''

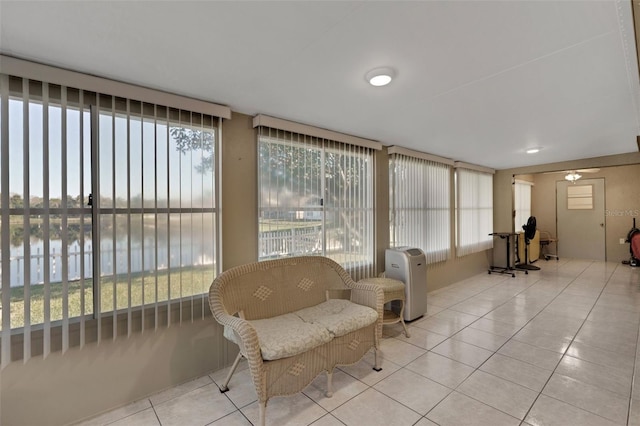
[258,120,374,280]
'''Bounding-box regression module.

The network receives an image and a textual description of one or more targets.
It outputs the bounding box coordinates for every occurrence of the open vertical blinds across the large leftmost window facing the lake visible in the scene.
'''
[0,74,220,366]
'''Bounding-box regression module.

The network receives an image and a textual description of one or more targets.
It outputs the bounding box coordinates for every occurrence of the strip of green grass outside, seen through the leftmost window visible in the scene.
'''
[3,265,215,328]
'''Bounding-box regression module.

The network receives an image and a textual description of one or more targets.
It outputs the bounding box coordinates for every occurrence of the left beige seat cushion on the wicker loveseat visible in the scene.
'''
[224,314,333,360]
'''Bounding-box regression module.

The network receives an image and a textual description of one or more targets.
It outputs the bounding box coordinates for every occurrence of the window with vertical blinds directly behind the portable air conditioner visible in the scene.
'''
[389,147,453,263]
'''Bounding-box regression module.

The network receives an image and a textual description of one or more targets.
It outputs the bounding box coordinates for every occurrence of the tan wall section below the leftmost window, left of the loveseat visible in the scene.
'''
[0,317,236,426]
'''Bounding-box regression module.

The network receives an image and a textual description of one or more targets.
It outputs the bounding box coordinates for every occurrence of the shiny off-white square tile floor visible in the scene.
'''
[82,260,640,426]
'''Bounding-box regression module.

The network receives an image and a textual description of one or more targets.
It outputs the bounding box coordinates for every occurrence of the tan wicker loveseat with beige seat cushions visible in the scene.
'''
[209,256,384,425]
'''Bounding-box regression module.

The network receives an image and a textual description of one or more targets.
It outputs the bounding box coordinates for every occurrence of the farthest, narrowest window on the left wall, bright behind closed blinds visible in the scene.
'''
[455,167,493,257]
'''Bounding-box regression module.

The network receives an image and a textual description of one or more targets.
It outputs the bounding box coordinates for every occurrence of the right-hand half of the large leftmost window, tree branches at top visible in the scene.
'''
[93,95,217,322]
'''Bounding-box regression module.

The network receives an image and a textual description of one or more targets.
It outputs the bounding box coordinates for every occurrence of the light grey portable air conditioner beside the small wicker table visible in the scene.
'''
[385,247,427,321]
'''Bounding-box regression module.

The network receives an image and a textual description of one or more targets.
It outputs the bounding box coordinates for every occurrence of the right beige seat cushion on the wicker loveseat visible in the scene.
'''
[294,299,378,337]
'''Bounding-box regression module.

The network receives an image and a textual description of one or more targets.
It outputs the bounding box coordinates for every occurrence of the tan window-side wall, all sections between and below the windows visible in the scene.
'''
[0,113,490,426]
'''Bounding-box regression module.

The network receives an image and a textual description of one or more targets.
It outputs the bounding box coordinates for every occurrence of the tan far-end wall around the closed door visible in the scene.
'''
[494,152,640,262]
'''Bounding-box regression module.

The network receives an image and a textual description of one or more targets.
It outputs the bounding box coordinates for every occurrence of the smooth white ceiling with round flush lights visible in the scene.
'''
[0,0,640,169]
